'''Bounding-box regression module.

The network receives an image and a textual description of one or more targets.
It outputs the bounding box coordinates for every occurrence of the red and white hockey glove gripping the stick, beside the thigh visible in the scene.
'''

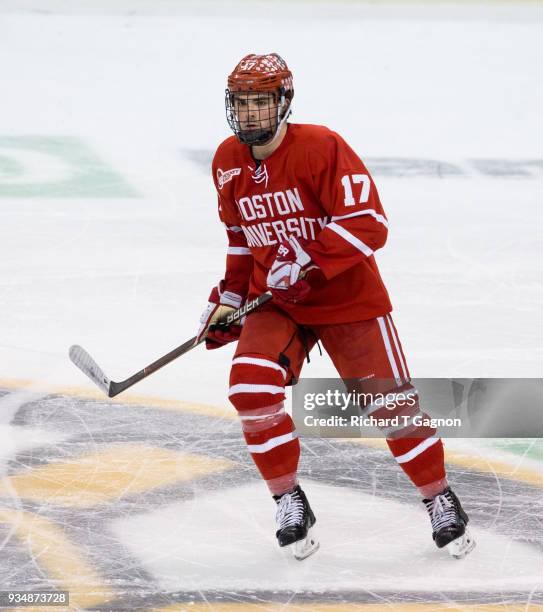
[197,280,242,349]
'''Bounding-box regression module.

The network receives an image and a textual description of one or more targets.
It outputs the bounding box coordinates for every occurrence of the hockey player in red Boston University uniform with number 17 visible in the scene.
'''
[198,53,474,559]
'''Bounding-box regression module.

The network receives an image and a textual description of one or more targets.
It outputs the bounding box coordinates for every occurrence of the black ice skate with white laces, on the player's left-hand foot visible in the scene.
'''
[273,485,319,561]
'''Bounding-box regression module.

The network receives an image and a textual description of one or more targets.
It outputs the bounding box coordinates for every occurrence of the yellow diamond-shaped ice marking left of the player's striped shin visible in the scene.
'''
[0,444,236,508]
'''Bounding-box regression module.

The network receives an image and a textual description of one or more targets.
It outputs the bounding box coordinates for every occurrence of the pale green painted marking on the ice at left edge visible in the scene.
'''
[0,136,139,198]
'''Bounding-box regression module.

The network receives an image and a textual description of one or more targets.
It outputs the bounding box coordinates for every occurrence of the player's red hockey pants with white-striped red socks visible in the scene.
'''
[229,305,445,494]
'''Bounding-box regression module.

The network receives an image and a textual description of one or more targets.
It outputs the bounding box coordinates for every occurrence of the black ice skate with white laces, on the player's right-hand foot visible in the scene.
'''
[422,487,475,559]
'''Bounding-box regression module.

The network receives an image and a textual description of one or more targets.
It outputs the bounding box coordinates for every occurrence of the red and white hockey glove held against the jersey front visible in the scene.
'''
[267,236,326,304]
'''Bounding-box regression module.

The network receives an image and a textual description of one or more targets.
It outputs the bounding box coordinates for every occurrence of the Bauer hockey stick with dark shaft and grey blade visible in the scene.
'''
[69,293,272,397]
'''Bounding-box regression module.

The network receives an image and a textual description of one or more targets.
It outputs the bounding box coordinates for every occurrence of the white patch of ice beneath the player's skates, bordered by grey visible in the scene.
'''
[116,480,543,592]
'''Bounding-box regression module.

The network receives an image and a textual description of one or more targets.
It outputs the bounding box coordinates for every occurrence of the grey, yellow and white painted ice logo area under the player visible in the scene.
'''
[0,395,543,610]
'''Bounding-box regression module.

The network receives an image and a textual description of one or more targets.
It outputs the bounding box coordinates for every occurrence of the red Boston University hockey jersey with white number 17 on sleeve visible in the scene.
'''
[213,124,392,324]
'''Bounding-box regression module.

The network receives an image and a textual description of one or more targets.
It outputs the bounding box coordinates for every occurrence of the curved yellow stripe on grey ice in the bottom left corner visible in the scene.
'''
[0,509,115,609]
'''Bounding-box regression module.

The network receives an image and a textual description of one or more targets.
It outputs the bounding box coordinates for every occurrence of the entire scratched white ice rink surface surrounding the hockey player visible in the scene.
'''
[0,0,543,610]
